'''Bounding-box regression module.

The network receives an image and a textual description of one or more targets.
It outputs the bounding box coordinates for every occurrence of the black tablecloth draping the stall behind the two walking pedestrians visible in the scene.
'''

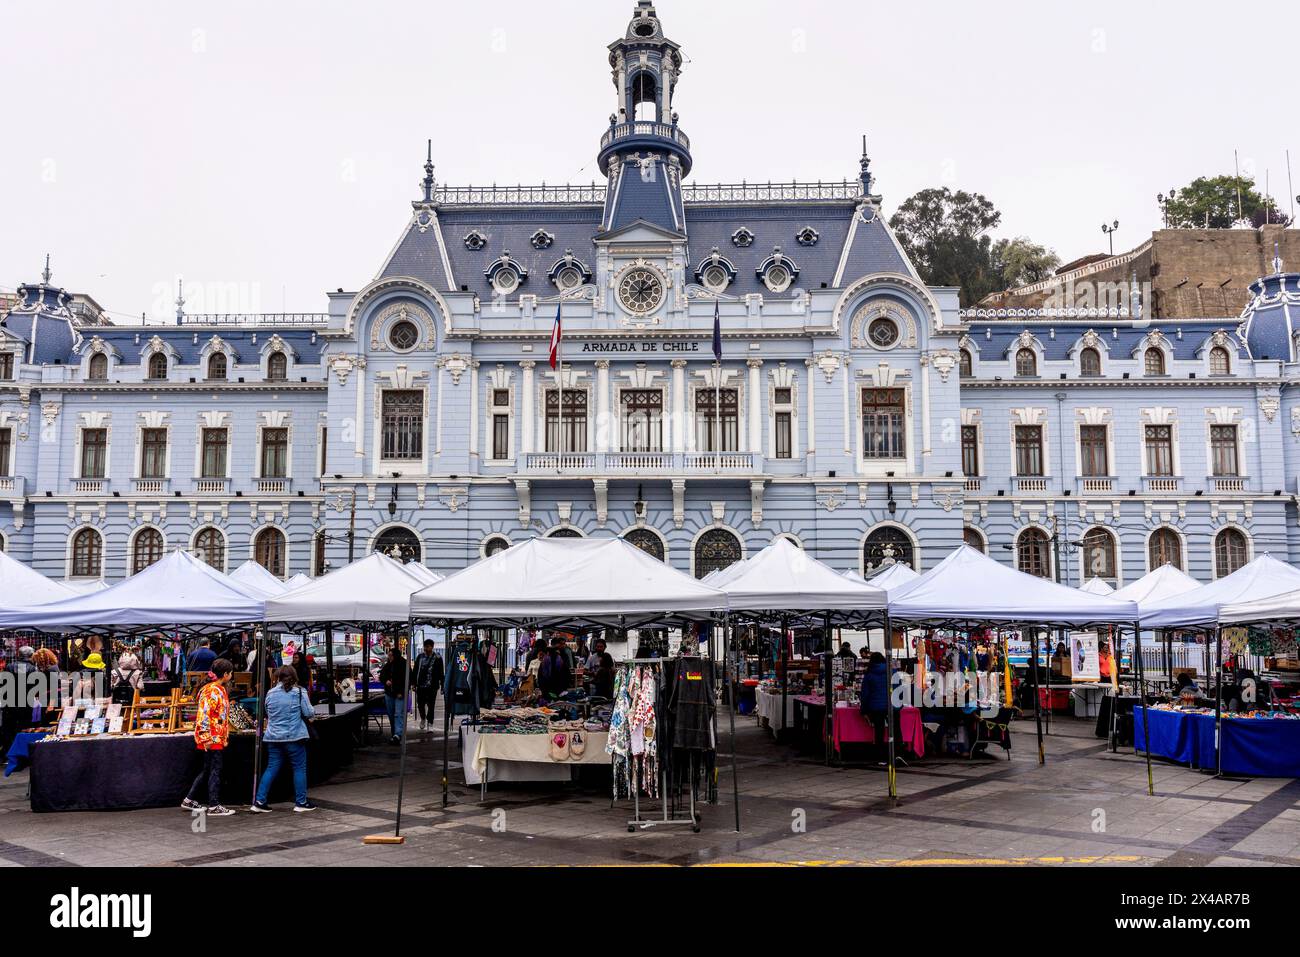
[31,705,363,811]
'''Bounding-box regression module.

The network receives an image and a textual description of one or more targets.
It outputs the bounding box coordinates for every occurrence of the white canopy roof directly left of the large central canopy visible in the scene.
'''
[265,551,425,628]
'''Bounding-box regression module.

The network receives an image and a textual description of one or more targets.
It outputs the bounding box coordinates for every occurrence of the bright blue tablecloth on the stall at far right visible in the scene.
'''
[1134,707,1300,778]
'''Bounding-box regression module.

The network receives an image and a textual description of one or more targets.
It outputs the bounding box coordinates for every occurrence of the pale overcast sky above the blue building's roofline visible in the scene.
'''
[0,0,1300,321]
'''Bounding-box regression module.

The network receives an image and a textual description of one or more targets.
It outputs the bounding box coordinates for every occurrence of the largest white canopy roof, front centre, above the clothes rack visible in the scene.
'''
[411,537,727,628]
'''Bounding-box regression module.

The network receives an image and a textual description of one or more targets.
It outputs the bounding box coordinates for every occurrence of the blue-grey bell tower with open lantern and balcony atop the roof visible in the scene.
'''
[597,0,692,233]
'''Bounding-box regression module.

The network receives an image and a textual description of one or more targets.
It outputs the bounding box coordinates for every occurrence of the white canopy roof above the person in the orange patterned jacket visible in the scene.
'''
[0,550,264,632]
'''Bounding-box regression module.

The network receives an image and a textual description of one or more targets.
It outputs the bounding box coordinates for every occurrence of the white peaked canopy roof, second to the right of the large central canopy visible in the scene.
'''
[889,545,1139,627]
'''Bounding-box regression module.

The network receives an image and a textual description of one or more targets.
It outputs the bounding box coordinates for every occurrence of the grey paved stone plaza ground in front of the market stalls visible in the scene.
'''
[0,718,1300,866]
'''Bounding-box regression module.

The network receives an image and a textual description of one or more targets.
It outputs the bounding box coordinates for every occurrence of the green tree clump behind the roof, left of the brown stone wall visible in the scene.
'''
[889,187,1060,306]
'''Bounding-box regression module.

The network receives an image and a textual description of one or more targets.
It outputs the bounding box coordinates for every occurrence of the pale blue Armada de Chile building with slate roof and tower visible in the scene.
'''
[0,3,1300,585]
